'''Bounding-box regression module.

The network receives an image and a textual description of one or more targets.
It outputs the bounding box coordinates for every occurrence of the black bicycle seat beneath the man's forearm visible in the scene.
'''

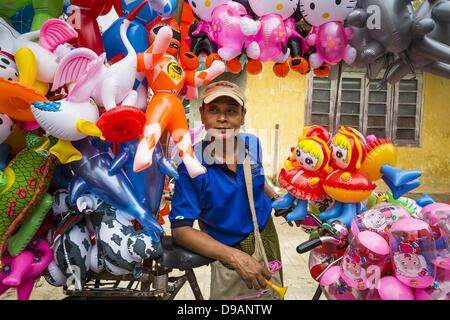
[158,236,214,270]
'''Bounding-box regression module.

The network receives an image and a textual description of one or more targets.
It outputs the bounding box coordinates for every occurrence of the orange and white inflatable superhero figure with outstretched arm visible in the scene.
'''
[133,18,225,178]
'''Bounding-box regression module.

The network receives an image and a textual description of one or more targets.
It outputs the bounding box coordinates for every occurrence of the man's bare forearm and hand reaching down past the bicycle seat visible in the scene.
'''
[172,226,270,290]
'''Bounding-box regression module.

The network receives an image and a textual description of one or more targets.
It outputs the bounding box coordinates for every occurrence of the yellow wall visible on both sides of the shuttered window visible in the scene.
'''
[245,64,450,193]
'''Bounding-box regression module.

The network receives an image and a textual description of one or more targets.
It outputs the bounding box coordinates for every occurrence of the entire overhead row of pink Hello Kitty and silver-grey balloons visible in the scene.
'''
[183,0,450,83]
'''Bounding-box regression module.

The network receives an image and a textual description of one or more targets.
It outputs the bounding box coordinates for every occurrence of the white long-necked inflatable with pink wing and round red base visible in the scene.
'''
[52,2,146,142]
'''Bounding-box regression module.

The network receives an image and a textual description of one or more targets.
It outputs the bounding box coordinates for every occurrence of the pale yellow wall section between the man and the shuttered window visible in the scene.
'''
[245,64,307,180]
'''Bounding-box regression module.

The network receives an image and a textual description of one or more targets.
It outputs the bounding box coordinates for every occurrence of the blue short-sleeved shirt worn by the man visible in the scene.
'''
[169,134,272,246]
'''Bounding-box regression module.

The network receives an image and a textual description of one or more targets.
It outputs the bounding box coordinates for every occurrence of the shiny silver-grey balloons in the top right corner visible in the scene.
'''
[348,0,450,84]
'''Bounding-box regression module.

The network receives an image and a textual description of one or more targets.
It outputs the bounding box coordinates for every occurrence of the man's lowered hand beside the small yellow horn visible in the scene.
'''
[230,249,270,290]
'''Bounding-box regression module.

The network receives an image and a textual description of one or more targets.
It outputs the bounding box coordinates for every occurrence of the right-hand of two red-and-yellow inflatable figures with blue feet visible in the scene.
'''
[320,127,421,226]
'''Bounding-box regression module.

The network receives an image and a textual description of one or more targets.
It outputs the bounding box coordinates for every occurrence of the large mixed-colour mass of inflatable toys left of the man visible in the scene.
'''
[0,0,225,299]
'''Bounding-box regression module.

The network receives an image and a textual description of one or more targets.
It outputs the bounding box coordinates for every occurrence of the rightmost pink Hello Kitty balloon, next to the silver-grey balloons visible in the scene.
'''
[300,0,357,68]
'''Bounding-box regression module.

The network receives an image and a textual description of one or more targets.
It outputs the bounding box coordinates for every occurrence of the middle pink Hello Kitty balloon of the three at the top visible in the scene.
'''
[246,0,306,63]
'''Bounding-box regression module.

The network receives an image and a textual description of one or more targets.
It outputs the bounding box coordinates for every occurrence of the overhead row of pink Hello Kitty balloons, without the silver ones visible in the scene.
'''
[188,0,356,77]
